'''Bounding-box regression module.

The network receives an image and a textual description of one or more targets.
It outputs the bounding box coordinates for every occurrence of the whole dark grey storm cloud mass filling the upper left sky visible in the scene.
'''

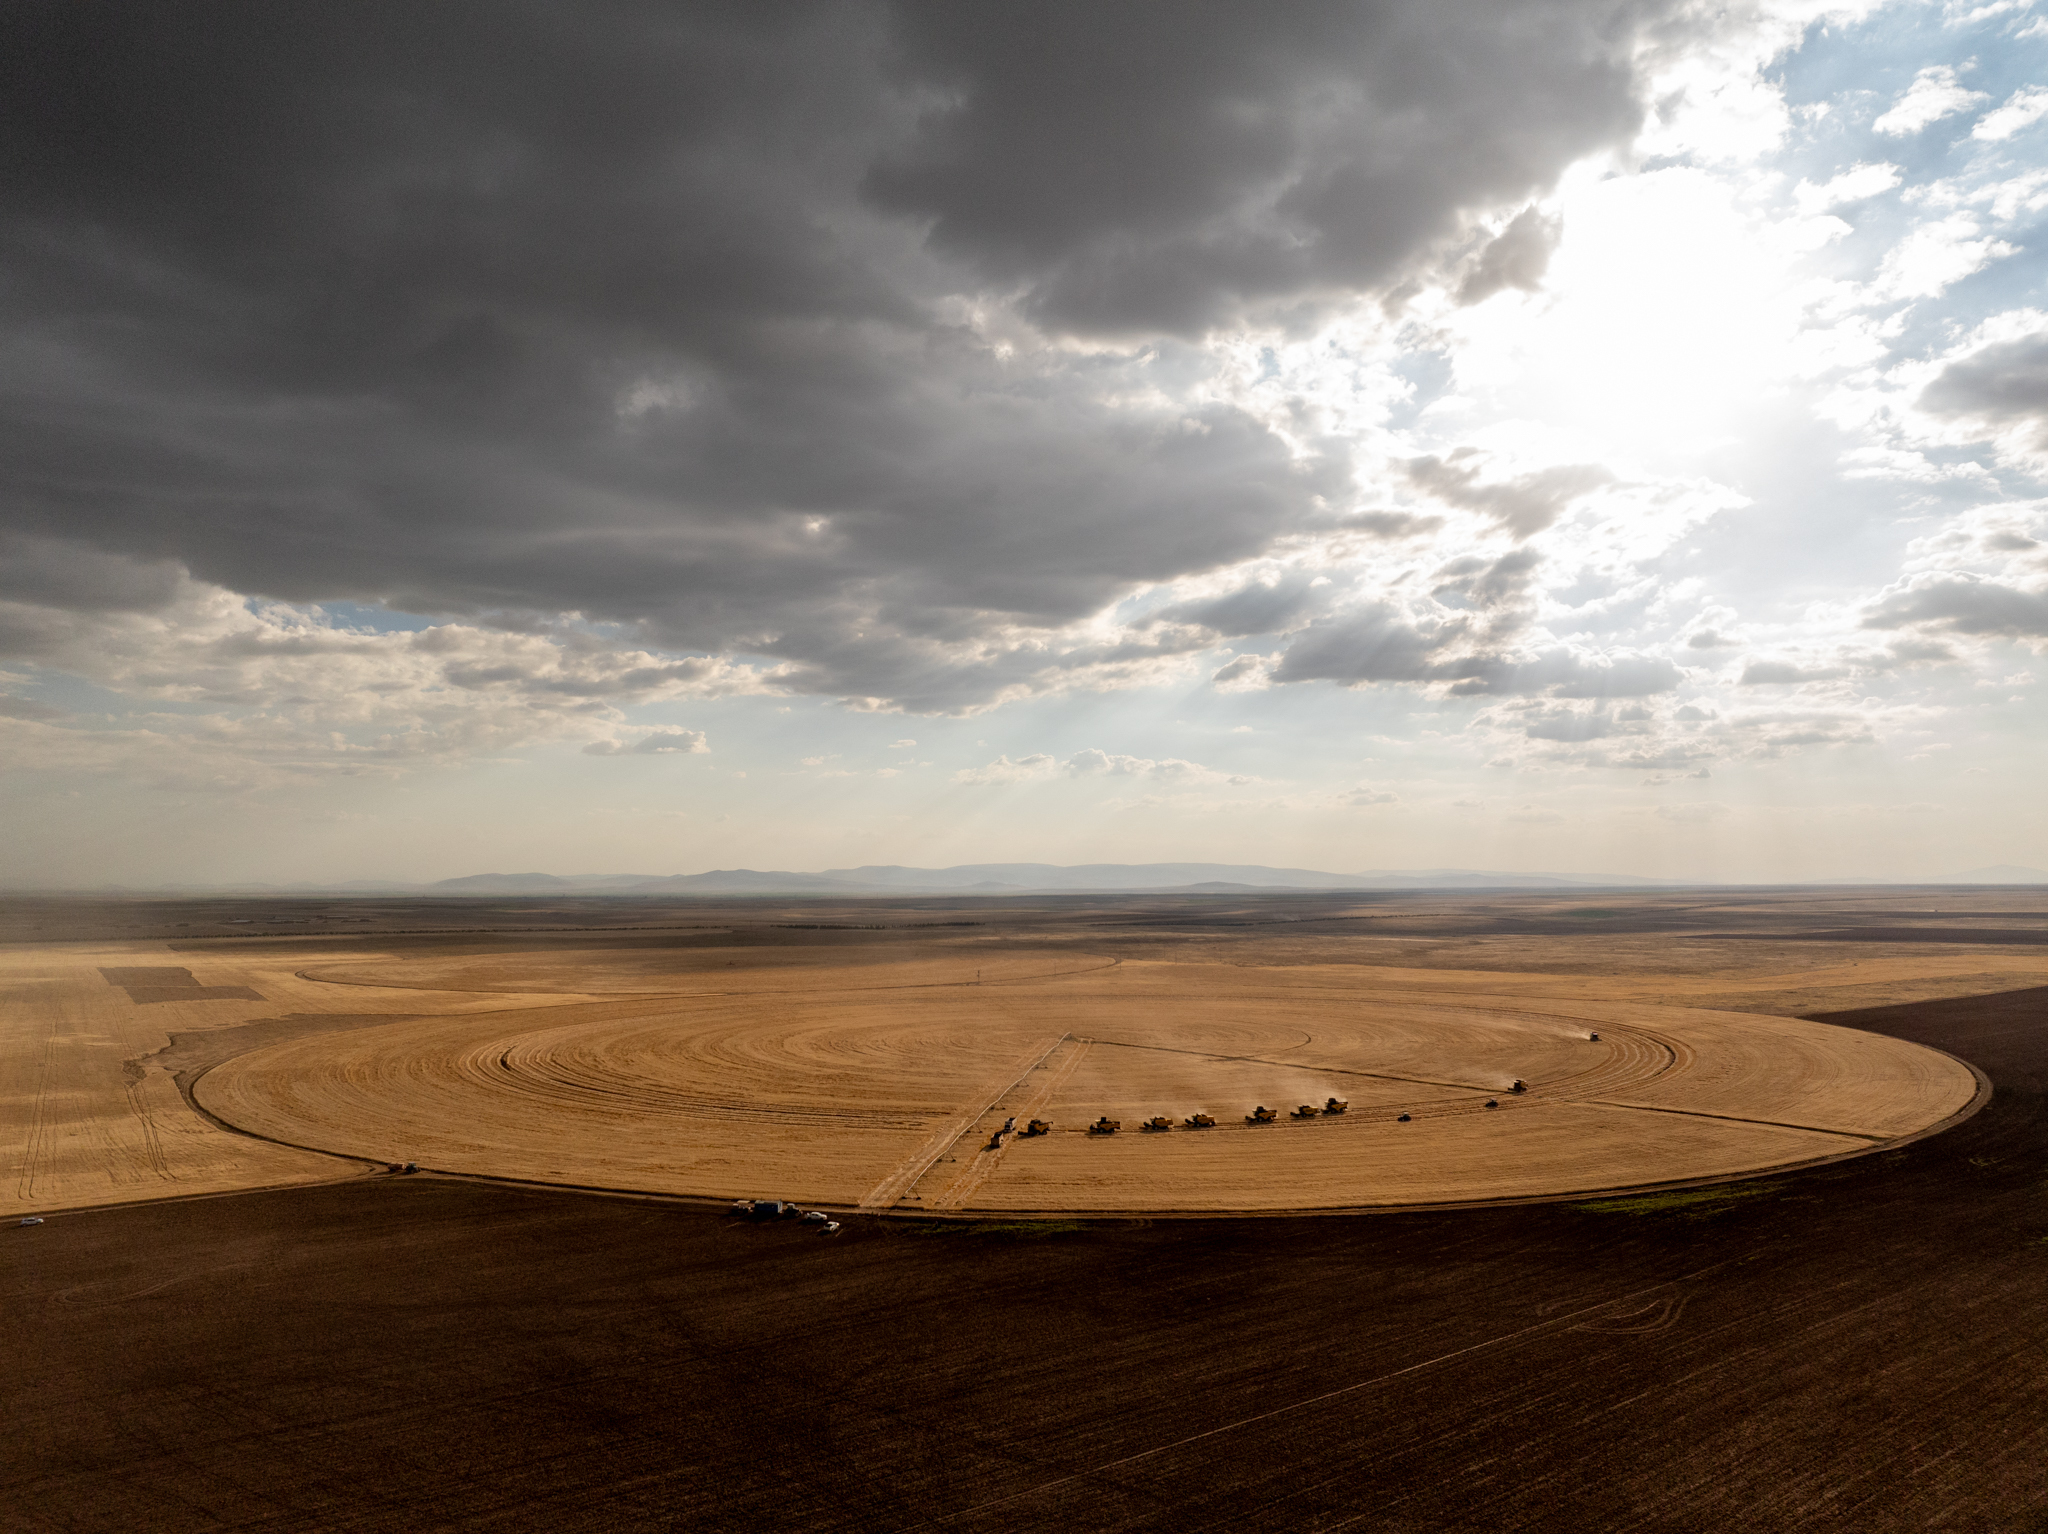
[0,0,1679,707]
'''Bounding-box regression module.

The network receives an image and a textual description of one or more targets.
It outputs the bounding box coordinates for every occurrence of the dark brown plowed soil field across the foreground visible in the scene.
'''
[0,989,2048,1534]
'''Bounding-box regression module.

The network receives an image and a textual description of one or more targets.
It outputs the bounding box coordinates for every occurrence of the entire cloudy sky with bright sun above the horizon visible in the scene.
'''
[0,0,2048,887]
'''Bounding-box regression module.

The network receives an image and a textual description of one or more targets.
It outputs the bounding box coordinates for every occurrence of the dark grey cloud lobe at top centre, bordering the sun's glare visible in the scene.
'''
[868,0,1640,334]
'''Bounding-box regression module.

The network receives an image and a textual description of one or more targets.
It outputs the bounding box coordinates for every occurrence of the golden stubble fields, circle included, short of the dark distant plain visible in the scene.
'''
[0,884,2023,1212]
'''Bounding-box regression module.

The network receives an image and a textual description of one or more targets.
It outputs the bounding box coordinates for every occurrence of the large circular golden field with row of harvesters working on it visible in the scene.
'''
[197,956,1978,1212]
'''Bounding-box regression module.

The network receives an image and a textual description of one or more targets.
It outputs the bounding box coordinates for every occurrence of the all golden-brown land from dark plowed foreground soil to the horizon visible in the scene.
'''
[0,891,2048,1215]
